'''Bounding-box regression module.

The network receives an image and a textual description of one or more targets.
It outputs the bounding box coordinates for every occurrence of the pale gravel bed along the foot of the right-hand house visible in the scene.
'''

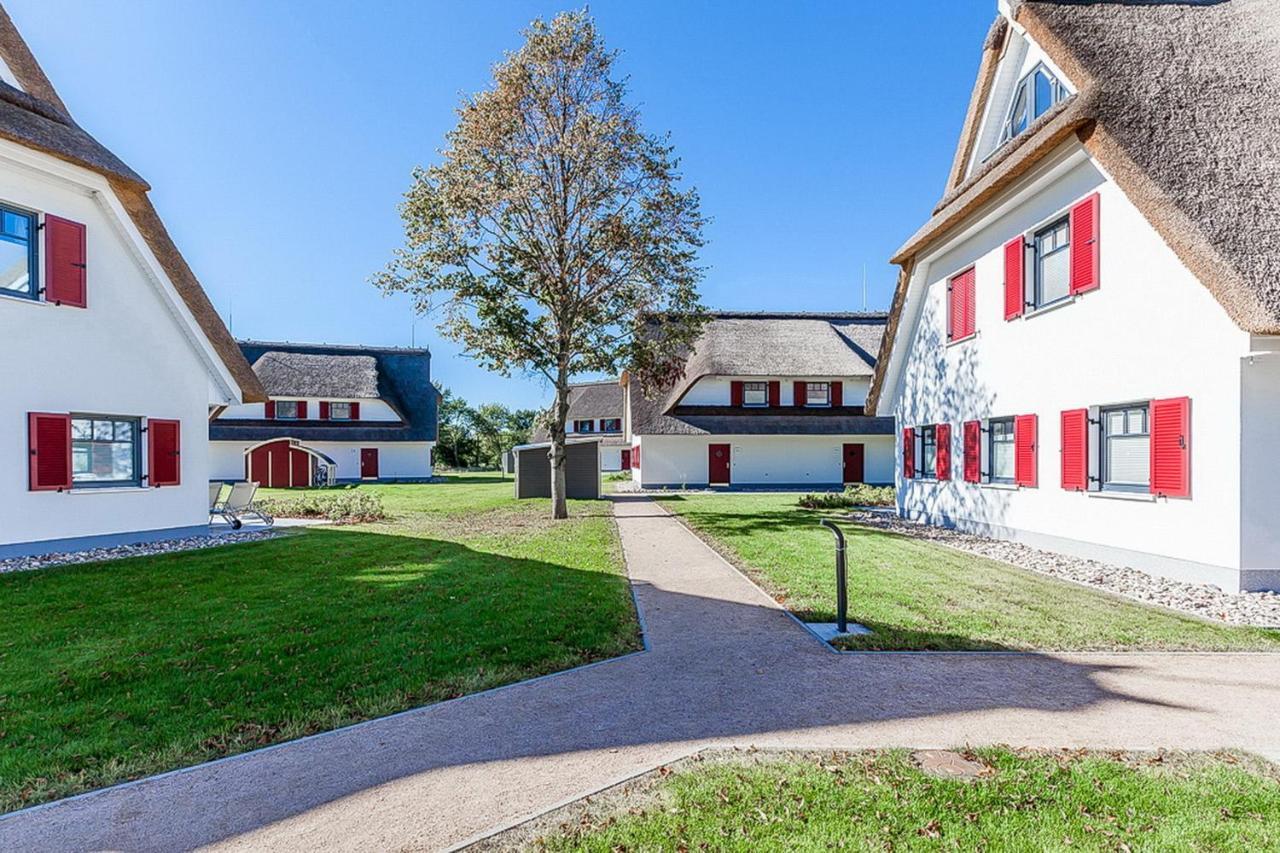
[849,512,1280,628]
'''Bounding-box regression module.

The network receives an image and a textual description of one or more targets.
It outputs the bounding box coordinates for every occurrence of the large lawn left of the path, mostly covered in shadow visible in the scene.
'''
[0,475,640,811]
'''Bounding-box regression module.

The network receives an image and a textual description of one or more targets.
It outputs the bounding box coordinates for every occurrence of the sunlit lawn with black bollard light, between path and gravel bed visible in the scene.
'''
[662,493,1280,651]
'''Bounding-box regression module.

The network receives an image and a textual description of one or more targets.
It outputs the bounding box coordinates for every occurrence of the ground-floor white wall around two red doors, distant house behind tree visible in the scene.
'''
[632,435,893,487]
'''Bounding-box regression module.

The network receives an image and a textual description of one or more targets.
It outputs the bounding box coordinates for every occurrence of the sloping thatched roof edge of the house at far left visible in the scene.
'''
[0,6,265,402]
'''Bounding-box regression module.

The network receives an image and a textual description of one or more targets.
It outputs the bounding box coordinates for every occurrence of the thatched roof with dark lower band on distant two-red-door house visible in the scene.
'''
[627,311,886,435]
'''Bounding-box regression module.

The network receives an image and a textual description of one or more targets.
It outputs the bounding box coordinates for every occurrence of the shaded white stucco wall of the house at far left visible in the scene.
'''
[0,142,229,547]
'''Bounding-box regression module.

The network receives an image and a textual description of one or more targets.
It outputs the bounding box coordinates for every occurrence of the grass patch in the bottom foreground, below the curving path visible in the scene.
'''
[535,748,1280,853]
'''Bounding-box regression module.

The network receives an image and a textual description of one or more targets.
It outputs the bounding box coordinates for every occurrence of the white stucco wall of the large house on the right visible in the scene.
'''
[879,149,1259,587]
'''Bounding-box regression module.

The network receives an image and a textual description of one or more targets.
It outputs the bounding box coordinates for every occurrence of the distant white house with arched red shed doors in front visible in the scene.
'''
[209,341,439,488]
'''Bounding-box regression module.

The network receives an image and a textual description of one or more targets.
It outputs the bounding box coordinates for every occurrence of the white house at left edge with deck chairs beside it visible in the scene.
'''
[0,9,262,558]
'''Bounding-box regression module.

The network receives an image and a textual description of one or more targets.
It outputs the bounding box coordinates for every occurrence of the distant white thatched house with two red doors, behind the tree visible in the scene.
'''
[622,313,893,488]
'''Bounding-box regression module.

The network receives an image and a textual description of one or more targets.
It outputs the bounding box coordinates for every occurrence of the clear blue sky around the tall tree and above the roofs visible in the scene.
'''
[5,0,996,406]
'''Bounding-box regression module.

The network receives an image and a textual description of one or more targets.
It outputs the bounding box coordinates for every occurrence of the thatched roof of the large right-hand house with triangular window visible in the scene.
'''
[870,0,1280,405]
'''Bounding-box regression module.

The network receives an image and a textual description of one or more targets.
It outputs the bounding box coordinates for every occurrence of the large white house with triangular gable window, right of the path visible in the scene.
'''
[869,0,1280,590]
